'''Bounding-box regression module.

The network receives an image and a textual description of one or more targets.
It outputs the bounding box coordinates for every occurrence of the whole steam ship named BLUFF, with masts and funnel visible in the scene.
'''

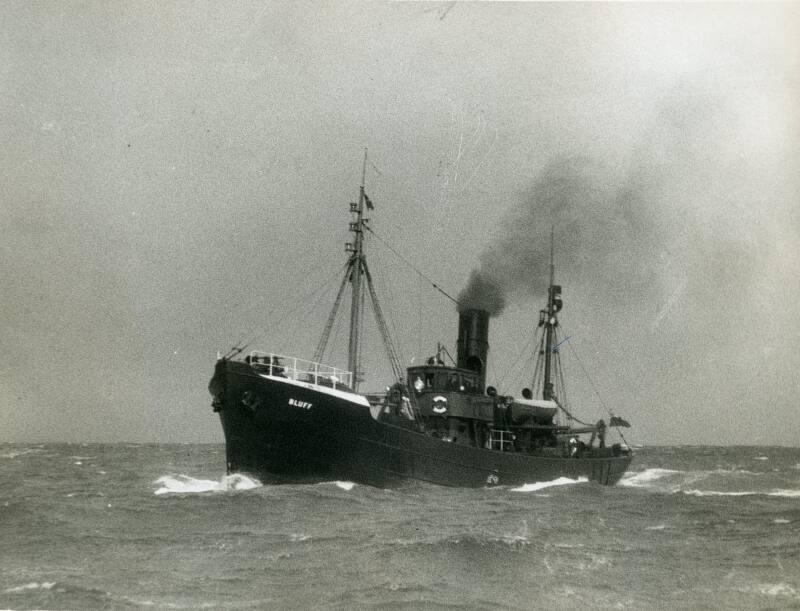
[209,155,632,487]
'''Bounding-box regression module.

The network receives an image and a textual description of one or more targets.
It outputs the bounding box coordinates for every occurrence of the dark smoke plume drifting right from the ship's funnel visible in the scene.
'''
[458,78,797,358]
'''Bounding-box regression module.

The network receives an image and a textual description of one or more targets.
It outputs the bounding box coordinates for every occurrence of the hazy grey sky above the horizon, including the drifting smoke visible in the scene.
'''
[0,1,800,445]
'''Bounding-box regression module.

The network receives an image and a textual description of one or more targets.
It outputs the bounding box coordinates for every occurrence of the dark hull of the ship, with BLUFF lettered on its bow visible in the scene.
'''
[209,360,631,487]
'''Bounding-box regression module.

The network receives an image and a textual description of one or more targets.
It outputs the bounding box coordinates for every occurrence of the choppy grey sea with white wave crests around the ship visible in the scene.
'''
[0,444,800,610]
